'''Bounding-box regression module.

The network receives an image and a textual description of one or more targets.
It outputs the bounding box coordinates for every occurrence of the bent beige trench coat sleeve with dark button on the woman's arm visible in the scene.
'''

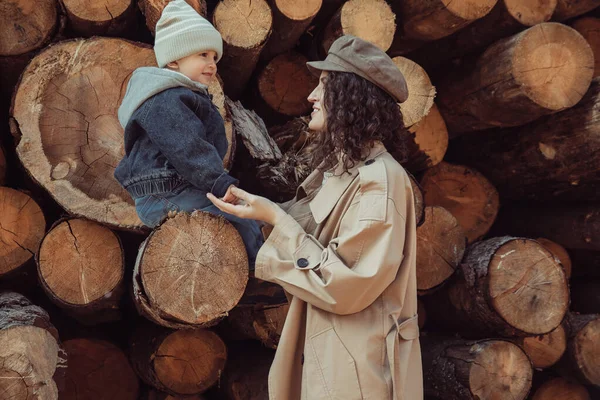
[255,177,406,314]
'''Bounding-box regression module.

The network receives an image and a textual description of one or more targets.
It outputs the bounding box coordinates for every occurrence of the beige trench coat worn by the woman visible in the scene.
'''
[256,144,423,400]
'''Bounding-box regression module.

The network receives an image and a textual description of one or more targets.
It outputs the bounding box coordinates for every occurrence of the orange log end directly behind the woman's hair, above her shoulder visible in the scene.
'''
[404,104,449,172]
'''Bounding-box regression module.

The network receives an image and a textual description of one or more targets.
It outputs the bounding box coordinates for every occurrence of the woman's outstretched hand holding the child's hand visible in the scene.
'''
[206,187,285,226]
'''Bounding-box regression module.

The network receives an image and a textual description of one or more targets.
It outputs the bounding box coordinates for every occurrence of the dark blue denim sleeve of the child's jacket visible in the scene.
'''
[142,90,238,197]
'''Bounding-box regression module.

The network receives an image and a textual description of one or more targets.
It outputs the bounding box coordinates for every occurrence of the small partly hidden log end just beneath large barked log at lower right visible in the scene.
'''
[514,325,567,369]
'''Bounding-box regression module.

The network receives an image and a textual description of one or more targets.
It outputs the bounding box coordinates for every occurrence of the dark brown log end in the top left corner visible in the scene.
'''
[0,0,59,56]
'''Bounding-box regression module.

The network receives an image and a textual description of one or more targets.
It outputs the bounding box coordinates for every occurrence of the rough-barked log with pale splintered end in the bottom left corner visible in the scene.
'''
[0,292,67,400]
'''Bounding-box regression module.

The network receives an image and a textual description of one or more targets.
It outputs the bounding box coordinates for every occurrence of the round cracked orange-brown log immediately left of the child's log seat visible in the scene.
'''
[36,218,125,325]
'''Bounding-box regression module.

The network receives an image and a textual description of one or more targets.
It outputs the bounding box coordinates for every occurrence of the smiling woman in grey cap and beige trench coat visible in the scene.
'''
[209,36,423,400]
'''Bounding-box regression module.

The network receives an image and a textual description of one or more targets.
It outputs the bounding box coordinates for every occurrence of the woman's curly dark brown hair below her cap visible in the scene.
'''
[313,72,414,172]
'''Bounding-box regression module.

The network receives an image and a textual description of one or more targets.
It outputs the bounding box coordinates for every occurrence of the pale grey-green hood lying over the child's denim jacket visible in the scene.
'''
[118,67,208,129]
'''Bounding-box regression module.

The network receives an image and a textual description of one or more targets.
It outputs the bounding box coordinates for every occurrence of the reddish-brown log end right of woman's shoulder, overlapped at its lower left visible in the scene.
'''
[421,162,500,243]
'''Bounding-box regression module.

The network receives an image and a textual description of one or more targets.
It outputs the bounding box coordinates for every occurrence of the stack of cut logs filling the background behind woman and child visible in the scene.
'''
[0,0,600,400]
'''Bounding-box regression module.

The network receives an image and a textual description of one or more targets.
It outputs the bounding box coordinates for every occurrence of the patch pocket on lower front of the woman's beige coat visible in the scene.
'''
[305,328,363,400]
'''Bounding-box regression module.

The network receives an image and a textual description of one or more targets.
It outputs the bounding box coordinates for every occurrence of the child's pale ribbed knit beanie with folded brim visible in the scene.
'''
[154,0,223,68]
